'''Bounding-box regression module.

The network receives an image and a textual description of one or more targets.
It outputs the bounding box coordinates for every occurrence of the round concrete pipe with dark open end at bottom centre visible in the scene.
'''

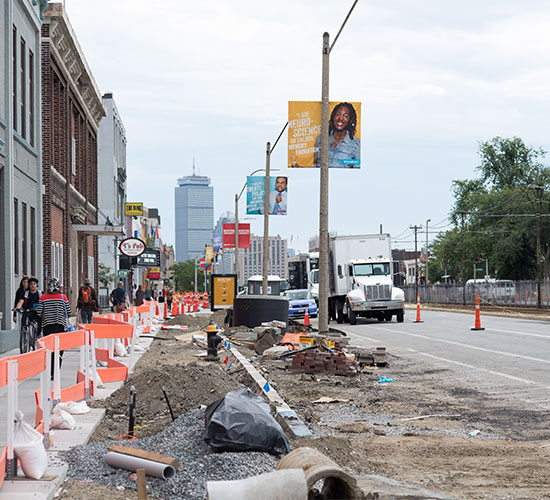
[276,447,363,500]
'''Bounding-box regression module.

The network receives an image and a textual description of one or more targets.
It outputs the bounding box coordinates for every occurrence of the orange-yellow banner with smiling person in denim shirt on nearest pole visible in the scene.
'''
[288,101,361,168]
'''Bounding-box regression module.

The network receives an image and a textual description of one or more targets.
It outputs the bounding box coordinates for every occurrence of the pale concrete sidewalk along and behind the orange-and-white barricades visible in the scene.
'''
[0,318,159,500]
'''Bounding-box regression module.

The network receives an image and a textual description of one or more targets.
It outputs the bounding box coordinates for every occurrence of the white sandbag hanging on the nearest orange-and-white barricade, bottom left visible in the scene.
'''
[13,411,48,479]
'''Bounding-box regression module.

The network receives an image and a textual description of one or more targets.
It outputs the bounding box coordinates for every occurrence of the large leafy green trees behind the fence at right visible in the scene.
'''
[430,137,550,282]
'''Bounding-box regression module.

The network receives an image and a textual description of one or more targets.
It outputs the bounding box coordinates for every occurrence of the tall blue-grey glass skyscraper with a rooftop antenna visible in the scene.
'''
[175,172,214,262]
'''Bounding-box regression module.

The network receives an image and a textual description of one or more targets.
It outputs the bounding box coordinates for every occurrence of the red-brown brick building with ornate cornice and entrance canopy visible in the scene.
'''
[41,3,108,304]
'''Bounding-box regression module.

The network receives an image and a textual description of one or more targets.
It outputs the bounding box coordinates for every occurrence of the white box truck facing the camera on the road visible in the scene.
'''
[328,234,405,325]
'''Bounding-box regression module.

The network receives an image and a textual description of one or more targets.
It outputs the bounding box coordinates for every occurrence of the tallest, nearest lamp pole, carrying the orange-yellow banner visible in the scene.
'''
[319,0,358,333]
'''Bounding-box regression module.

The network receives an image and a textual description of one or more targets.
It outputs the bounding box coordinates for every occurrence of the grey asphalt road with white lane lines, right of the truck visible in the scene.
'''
[324,310,550,410]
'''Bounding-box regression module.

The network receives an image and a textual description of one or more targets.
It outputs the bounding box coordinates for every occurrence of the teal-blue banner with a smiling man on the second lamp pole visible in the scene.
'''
[246,176,288,215]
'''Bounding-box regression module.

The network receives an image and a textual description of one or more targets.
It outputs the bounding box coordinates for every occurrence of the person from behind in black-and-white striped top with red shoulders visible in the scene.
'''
[36,278,75,380]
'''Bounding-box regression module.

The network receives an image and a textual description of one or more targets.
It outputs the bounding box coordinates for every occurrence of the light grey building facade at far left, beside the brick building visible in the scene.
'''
[0,0,47,336]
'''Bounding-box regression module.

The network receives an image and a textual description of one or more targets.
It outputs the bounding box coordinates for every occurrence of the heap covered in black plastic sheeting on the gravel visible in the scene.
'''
[204,389,290,455]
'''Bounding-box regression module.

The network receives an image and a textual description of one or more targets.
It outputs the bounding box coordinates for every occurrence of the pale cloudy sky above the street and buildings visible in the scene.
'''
[62,0,550,251]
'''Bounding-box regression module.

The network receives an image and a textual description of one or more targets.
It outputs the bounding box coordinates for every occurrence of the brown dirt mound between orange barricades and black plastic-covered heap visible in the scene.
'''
[91,362,243,442]
